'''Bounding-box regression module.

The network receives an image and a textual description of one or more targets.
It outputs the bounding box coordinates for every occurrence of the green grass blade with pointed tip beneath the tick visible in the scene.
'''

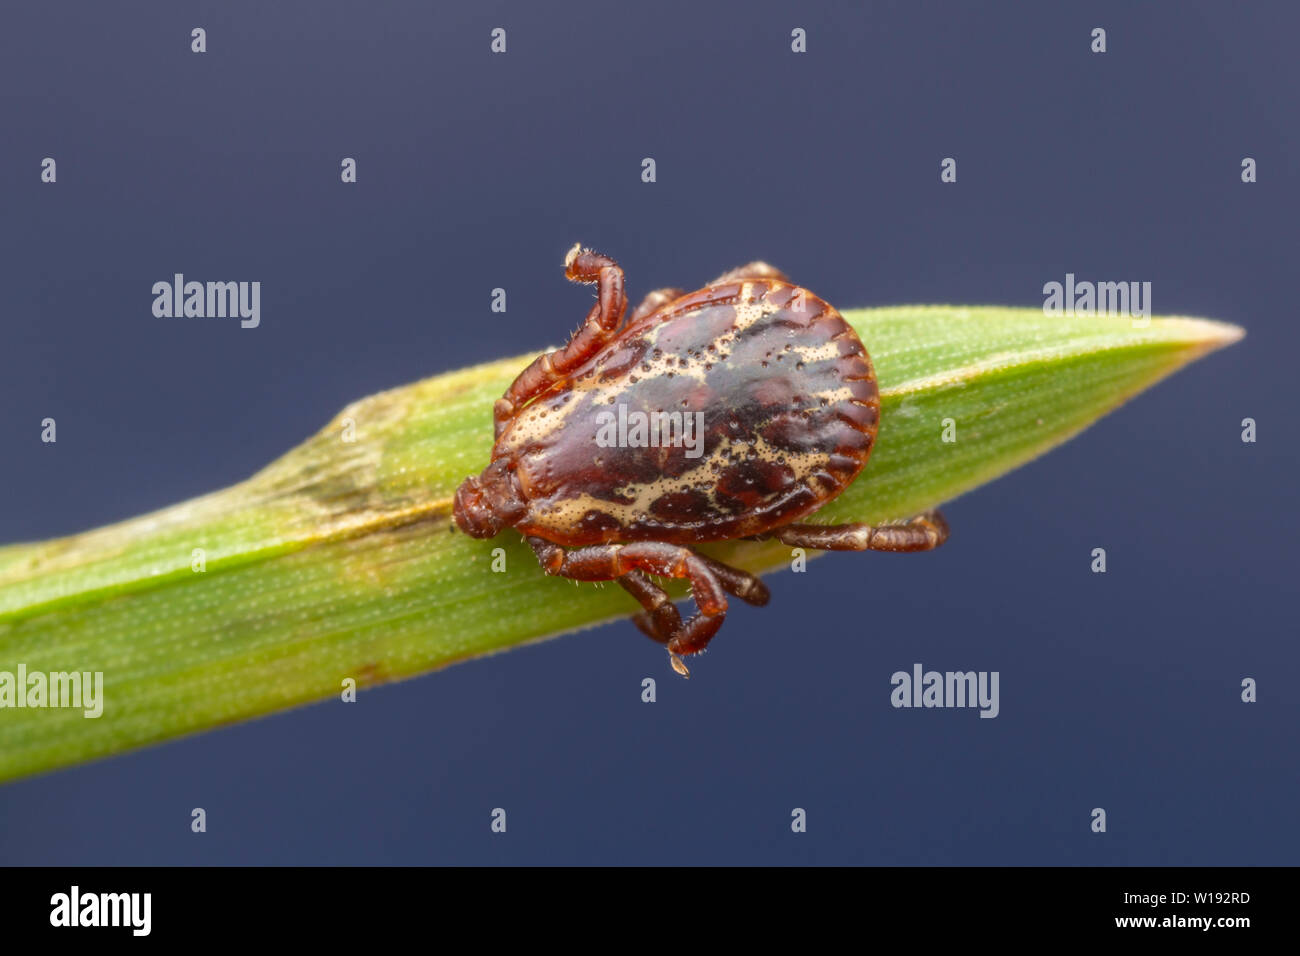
[0,307,1242,780]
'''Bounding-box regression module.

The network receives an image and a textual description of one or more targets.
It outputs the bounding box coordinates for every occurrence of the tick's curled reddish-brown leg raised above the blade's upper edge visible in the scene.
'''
[493,246,628,436]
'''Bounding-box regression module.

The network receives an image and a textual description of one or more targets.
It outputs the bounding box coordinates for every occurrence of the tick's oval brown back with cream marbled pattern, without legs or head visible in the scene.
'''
[493,278,880,546]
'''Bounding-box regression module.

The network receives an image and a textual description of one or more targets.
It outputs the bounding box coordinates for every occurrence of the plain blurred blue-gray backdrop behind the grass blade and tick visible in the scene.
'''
[0,0,1300,864]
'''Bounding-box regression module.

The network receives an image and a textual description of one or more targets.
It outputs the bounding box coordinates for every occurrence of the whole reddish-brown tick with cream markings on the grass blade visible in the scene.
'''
[454,246,948,675]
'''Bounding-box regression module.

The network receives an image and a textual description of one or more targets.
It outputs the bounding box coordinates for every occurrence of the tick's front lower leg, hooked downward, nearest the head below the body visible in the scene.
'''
[528,537,740,674]
